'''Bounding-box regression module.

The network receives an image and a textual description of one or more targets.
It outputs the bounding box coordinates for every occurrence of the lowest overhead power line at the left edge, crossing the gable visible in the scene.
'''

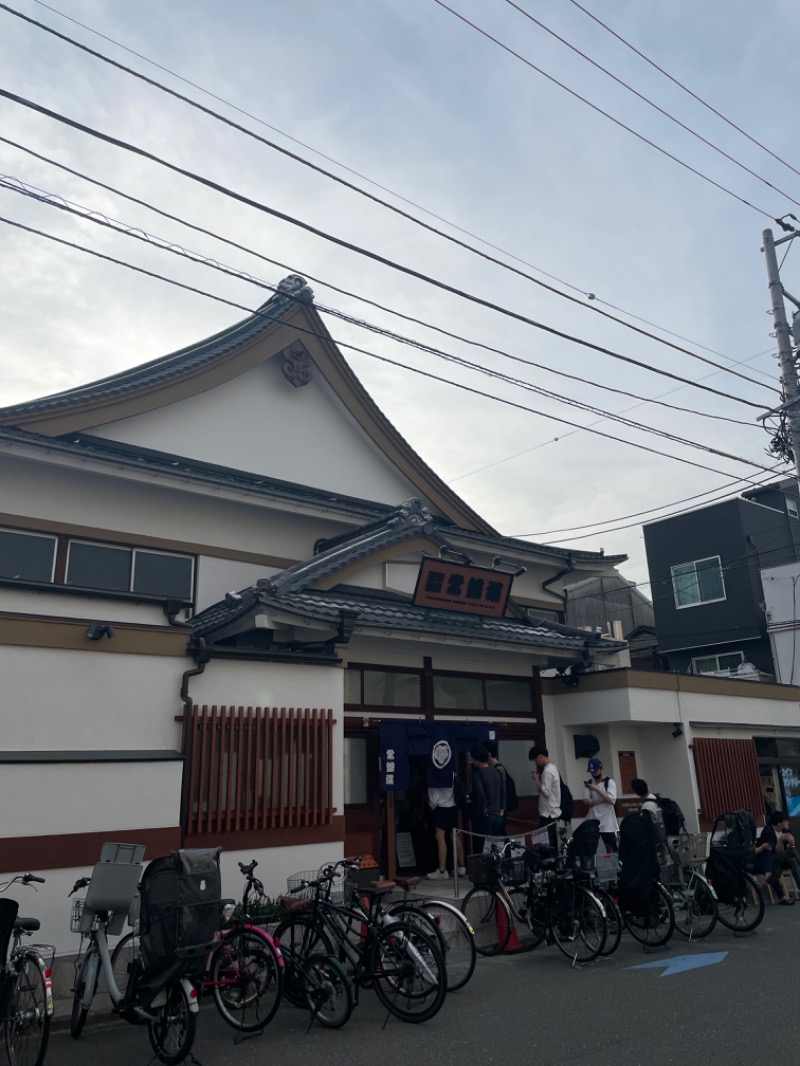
[0,216,789,486]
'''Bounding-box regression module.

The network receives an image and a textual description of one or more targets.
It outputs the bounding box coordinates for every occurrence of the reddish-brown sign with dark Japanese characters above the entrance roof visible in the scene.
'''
[414,559,513,618]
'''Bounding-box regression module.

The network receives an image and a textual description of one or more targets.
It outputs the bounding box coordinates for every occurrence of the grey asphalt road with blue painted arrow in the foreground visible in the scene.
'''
[46,904,800,1066]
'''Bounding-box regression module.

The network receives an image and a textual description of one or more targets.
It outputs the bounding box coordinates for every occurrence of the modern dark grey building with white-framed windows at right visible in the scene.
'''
[644,479,800,680]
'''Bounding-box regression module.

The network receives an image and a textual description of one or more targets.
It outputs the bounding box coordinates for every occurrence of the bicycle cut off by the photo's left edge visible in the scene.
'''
[0,873,55,1066]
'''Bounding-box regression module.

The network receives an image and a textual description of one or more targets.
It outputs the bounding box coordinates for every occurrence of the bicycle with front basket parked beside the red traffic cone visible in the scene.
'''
[462,841,608,965]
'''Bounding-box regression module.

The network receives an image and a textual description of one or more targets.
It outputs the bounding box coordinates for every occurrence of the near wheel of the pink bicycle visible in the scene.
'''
[210,928,284,1033]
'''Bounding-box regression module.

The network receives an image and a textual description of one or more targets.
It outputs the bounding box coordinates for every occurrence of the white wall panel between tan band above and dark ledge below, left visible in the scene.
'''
[0,646,183,752]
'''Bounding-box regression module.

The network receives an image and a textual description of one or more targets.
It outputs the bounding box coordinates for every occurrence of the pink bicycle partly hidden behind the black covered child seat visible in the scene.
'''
[111,859,284,1033]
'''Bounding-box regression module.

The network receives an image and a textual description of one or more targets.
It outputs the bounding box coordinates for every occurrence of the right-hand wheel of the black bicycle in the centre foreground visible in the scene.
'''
[369,922,447,1022]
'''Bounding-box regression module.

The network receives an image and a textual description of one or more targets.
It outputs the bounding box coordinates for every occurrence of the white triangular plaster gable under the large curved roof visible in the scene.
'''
[87,359,418,503]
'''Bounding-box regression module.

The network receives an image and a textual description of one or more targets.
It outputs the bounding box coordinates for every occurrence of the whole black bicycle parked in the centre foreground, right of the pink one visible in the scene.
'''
[275,859,447,1022]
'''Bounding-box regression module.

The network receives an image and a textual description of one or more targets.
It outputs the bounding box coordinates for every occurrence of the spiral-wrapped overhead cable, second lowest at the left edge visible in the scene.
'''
[0,176,765,469]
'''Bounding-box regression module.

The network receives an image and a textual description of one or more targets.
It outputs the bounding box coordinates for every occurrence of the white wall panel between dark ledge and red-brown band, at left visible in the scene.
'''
[0,761,182,840]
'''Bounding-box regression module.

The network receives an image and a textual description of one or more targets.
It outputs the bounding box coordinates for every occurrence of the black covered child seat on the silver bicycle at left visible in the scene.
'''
[137,847,222,1006]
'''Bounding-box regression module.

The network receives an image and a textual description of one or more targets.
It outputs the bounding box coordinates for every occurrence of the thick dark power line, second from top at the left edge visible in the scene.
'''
[0,90,777,410]
